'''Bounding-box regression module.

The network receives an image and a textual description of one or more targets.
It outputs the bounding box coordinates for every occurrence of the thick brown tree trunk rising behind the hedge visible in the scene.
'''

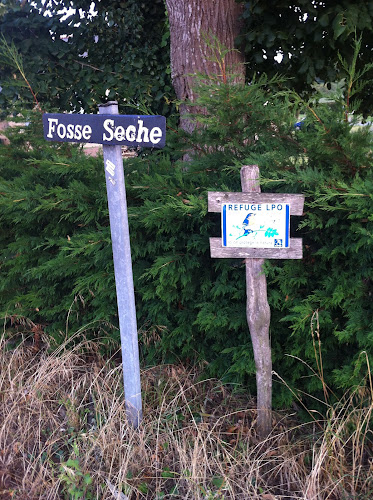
[166,0,245,132]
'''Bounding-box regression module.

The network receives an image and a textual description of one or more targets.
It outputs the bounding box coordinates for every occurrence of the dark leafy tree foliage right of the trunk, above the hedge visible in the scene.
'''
[238,0,373,115]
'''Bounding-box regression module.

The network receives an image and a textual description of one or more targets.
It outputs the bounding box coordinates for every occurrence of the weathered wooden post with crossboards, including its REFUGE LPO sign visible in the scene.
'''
[208,165,304,439]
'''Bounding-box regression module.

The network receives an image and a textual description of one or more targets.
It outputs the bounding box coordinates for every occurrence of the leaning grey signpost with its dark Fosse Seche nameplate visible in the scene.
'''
[43,101,166,428]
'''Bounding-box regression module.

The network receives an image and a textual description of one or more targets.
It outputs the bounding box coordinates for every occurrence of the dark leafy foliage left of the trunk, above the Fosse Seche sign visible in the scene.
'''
[0,0,173,114]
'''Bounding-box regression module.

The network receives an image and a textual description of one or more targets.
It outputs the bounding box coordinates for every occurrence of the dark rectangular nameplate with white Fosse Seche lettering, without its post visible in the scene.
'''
[43,113,166,148]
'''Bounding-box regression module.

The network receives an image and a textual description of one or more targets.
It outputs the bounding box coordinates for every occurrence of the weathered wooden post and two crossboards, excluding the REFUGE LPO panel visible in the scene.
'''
[208,165,304,439]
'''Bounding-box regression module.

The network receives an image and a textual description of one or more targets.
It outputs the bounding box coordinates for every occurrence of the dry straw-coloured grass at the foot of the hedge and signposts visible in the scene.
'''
[0,330,373,500]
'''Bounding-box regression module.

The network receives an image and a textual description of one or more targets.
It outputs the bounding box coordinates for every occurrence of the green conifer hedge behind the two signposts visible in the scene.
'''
[0,78,373,405]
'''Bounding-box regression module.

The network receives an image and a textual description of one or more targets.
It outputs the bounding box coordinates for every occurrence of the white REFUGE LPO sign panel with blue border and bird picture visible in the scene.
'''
[222,202,290,248]
